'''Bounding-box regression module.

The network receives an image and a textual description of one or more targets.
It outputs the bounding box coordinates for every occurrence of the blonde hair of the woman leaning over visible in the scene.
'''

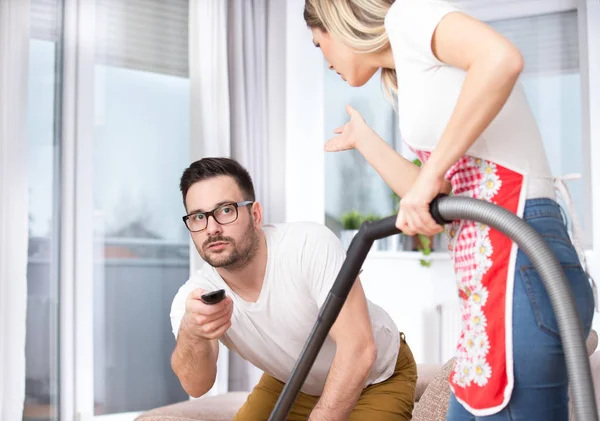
[304,0,398,101]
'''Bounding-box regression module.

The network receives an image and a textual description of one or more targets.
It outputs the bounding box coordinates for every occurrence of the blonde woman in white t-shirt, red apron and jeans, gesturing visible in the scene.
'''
[304,0,594,421]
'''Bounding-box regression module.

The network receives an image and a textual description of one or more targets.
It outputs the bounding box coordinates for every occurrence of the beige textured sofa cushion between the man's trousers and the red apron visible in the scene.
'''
[412,358,455,421]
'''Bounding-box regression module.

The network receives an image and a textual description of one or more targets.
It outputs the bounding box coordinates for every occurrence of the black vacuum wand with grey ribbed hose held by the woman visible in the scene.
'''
[269,196,598,421]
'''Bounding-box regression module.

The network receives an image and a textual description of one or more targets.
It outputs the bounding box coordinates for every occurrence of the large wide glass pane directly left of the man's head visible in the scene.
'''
[93,4,190,415]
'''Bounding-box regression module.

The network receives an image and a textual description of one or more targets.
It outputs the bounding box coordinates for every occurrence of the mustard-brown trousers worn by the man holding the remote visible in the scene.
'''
[233,333,417,421]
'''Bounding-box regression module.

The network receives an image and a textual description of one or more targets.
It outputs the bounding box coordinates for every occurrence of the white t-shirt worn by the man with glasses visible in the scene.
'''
[171,222,400,396]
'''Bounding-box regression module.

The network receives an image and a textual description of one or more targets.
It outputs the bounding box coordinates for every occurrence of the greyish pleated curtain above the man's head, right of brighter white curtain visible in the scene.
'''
[227,0,285,390]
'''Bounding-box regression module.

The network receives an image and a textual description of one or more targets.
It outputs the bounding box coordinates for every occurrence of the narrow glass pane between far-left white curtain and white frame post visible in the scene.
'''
[23,39,59,421]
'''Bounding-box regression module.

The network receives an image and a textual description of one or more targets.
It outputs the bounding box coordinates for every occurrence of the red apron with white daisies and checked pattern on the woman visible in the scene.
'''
[415,151,527,416]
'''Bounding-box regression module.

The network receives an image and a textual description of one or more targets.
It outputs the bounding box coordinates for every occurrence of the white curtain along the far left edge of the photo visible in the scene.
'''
[0,0,29,420]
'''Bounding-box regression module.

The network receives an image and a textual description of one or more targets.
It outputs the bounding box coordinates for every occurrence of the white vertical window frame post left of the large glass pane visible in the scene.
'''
[57,0,195,421]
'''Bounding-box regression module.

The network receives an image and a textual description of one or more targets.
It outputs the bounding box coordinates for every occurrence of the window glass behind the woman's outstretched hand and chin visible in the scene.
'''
[324,64,398,235]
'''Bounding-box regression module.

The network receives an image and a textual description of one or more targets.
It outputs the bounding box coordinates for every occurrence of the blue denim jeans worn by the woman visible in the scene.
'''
[446,199,594,421]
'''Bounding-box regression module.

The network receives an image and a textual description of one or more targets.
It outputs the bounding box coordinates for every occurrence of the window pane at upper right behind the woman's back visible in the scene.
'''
[492,11,592,248]
